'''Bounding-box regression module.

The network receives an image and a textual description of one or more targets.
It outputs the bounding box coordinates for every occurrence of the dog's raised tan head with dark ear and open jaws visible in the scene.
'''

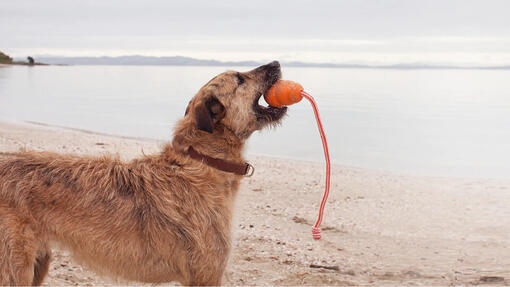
[185,61,287,139]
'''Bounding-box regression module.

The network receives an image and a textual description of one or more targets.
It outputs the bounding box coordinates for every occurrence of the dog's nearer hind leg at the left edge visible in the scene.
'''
[0,204,37,286]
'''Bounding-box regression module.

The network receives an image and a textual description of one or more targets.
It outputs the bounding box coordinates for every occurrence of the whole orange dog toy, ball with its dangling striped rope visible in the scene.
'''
[264,80,331,239]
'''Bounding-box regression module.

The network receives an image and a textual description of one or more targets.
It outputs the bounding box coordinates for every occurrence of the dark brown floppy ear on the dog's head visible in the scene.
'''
[195,97,225,133]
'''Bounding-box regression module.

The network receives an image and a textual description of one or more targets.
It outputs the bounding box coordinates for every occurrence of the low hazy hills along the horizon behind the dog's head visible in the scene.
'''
[13,55,510,70]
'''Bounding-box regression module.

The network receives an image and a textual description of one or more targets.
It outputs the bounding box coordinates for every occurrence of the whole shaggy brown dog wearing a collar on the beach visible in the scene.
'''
[0,62,286,285]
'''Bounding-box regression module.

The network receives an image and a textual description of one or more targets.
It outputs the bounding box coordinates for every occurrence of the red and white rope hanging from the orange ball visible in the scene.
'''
[301,91,331,239]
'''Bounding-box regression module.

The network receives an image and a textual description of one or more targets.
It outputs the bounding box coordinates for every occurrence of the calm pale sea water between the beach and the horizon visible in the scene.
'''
[0,66,510,178]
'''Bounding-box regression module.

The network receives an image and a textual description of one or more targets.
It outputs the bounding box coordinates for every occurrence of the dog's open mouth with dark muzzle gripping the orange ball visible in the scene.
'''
[253,61,287,122]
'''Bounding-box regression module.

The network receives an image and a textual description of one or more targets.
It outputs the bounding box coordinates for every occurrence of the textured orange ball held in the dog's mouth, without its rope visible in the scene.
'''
[264,80,303,108]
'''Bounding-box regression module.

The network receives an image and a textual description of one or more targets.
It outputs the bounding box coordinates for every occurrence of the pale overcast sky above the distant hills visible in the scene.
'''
[0,0,510,66]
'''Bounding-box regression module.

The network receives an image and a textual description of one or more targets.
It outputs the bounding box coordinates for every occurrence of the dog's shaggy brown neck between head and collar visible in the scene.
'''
[172,121,244,163]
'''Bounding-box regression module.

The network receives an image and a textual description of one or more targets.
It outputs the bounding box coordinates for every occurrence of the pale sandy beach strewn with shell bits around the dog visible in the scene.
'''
[0,123,510,285]
